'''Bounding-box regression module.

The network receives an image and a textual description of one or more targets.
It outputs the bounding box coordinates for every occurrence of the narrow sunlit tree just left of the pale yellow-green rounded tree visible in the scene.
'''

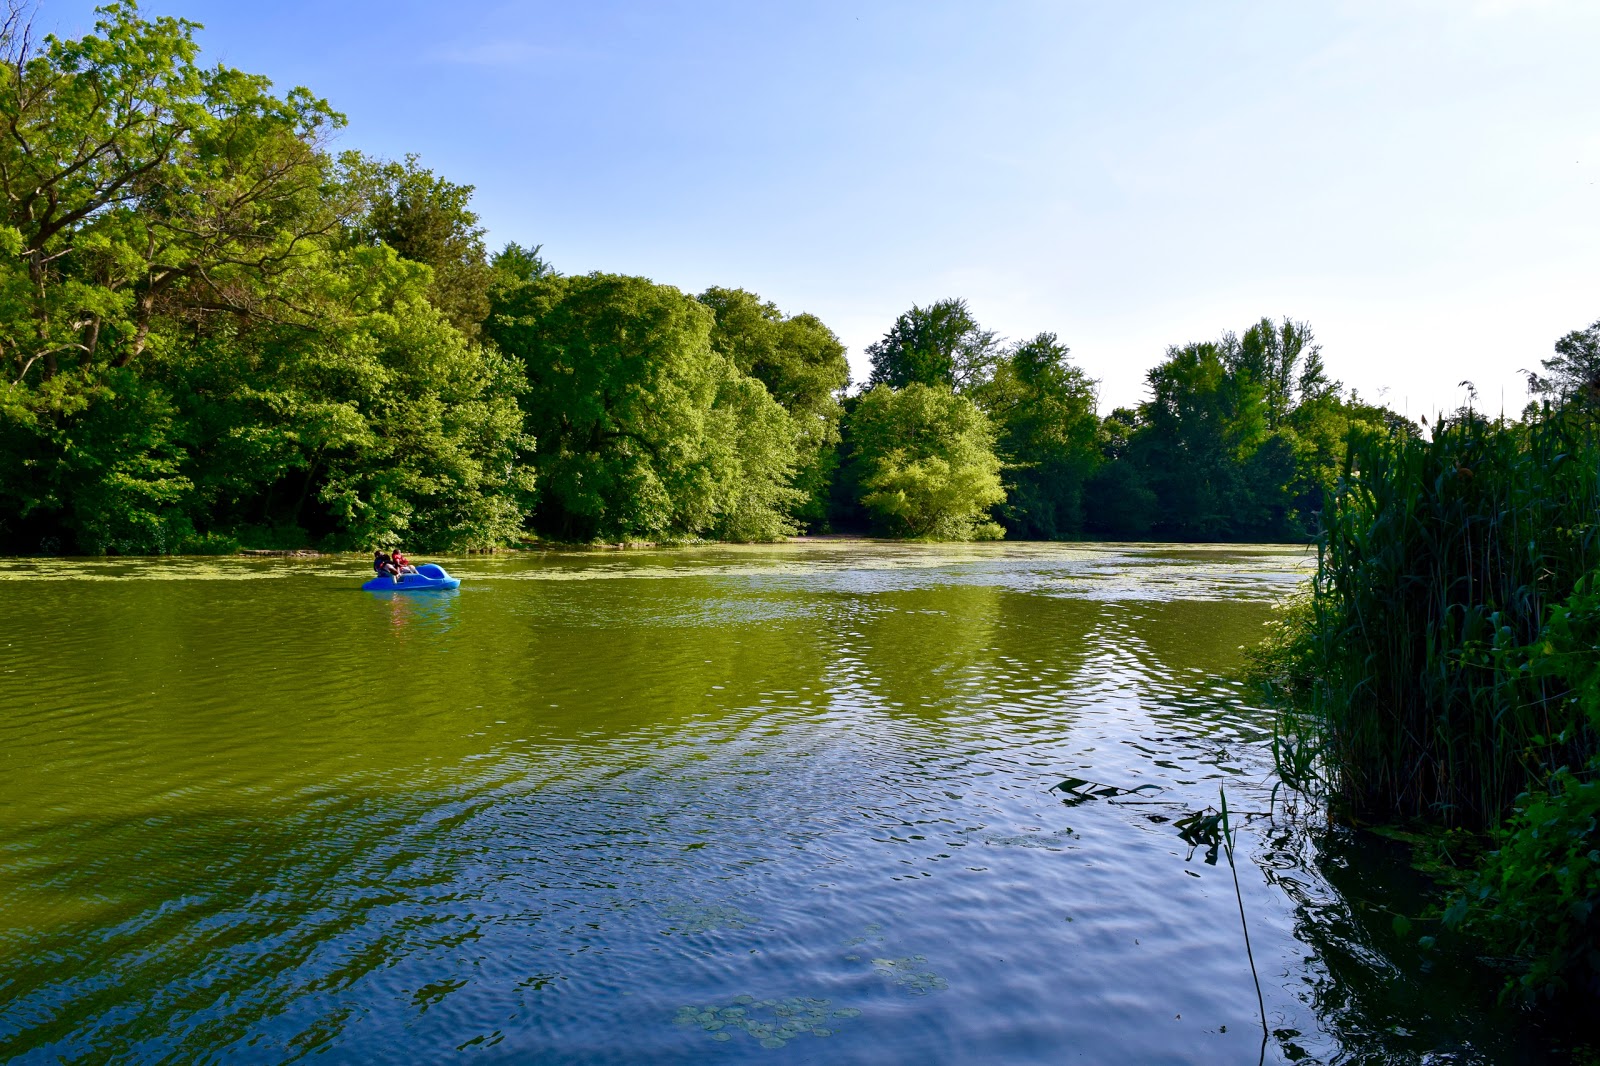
[699,287,850,528]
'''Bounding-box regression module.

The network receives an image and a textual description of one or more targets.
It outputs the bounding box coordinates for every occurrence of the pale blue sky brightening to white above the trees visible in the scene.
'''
[38,0,1600,416]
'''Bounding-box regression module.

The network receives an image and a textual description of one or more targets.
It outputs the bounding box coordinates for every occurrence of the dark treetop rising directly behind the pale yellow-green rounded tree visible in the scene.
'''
[867,299,1000,392]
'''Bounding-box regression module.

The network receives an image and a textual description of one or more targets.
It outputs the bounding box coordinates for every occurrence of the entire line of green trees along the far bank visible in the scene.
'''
[0,3,1414,554]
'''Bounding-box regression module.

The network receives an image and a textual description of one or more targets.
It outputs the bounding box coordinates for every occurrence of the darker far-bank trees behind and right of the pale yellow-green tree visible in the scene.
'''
[838,299,1418,541]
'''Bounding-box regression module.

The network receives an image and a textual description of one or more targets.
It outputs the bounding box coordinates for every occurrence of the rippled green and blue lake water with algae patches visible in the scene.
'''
[0,541,1546,1064]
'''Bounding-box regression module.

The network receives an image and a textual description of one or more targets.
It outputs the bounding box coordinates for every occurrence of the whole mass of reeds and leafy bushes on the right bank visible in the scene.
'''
[1253,323,1600,1007]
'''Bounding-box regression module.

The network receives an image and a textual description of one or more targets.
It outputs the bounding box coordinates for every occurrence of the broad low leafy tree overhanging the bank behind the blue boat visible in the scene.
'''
[106,248,533,551]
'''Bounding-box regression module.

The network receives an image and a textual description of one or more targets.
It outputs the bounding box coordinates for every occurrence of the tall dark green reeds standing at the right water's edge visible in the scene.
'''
[1258,403,1600,829]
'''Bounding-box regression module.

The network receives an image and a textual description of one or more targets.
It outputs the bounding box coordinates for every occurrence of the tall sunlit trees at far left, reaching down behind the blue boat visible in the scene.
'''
[0,3,528,552]
